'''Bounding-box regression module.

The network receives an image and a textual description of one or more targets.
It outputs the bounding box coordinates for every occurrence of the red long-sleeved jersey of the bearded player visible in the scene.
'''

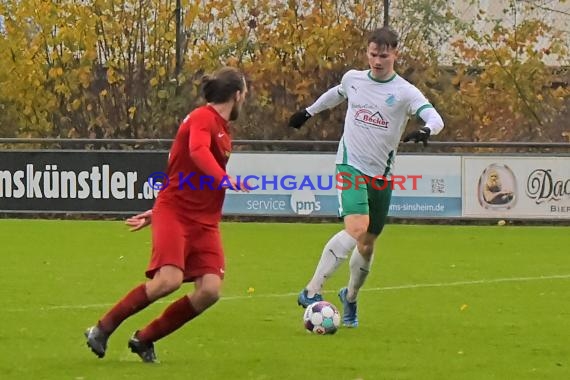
[155,106,232,225]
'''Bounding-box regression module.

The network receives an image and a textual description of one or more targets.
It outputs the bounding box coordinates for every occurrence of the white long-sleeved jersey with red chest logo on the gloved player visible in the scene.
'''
[307,70,434,177]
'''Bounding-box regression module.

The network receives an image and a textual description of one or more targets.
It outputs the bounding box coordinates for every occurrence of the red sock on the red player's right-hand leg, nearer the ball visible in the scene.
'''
[137,296,200,342]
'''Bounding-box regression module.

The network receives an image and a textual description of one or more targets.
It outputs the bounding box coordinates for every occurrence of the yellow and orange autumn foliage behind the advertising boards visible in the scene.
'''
[0,0,570,141]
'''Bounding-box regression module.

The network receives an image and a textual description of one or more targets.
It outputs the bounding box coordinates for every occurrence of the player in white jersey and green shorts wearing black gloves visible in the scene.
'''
[289,27,443,327]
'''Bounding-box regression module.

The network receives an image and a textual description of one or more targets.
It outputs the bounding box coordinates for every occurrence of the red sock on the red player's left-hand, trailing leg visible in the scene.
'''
[98,284,151,334]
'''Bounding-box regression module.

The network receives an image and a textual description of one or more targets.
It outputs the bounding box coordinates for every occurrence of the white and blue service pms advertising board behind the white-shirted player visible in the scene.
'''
[224,153,461,218]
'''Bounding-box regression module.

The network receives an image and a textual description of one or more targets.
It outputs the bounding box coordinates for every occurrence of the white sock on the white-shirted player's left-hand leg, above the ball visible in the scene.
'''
[307,230,360,297]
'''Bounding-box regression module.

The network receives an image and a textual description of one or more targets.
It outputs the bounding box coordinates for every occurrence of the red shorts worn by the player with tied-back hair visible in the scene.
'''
[146,206,225,282]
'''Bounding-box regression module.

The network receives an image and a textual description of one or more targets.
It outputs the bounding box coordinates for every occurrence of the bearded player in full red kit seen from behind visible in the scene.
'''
[85,67,247,362]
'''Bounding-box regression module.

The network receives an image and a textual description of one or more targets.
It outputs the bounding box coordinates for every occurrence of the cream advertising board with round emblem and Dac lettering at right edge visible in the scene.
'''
[463,156,570,219]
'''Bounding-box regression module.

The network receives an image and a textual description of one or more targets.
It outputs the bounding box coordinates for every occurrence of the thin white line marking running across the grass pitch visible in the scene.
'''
[5,274,570,313]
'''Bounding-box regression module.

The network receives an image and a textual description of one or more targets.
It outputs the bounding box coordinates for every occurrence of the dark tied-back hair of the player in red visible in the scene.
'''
[202,67,245,103]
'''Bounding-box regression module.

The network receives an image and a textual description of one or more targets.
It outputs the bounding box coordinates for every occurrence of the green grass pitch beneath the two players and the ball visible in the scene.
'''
[0,220,570,380]
